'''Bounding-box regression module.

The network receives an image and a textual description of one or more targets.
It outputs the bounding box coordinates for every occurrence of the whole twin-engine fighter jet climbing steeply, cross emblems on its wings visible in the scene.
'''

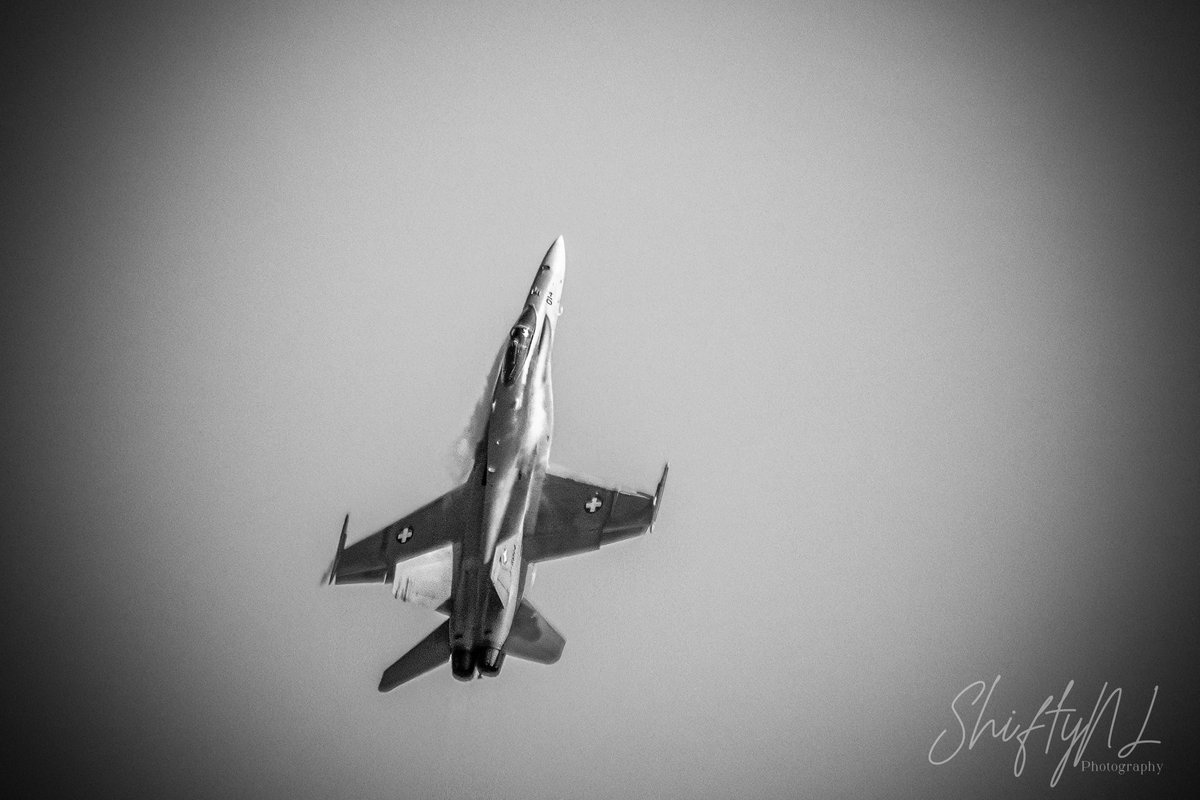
[326,236,667,692]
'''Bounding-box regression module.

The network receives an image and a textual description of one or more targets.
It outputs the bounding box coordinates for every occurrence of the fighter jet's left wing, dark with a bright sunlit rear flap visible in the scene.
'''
[328,486,466,587]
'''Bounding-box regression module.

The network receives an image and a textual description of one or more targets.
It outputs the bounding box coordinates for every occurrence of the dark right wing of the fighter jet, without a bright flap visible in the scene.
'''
[522,467,667,563]
